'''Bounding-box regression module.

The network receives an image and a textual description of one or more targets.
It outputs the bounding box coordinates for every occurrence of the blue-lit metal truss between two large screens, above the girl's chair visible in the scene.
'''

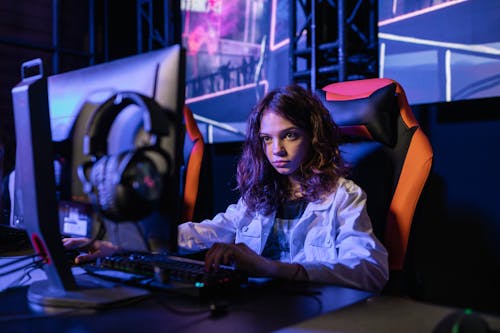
[289,0,378,91]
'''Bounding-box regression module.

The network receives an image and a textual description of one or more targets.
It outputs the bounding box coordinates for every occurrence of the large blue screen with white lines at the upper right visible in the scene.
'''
[378,0,500,104]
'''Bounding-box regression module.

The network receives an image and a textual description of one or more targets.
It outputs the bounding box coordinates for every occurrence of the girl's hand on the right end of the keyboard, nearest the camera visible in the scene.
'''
[205,243,275,276]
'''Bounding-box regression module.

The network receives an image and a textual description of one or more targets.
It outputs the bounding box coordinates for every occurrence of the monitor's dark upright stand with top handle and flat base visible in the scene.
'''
[12,59,149,312]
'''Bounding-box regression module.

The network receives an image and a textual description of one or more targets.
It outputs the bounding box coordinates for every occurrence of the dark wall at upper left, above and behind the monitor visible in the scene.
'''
[0,0,144,171]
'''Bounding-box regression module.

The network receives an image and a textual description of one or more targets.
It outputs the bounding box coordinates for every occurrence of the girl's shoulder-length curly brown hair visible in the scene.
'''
[237,84,346,214]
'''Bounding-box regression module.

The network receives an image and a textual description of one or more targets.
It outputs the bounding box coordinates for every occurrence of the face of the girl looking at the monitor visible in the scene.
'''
[259,110,310,175]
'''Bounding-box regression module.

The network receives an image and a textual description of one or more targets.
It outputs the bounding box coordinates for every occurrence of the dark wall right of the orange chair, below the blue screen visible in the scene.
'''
[409,98,500,313]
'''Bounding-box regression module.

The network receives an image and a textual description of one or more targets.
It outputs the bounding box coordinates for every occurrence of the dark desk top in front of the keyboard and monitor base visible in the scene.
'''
[0,255,373,333]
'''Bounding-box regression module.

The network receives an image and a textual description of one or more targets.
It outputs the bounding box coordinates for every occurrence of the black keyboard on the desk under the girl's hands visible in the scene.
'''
[86,253,248,288]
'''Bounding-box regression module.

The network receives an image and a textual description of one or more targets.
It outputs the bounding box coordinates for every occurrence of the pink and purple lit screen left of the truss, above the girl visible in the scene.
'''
[181,0,269,99]
